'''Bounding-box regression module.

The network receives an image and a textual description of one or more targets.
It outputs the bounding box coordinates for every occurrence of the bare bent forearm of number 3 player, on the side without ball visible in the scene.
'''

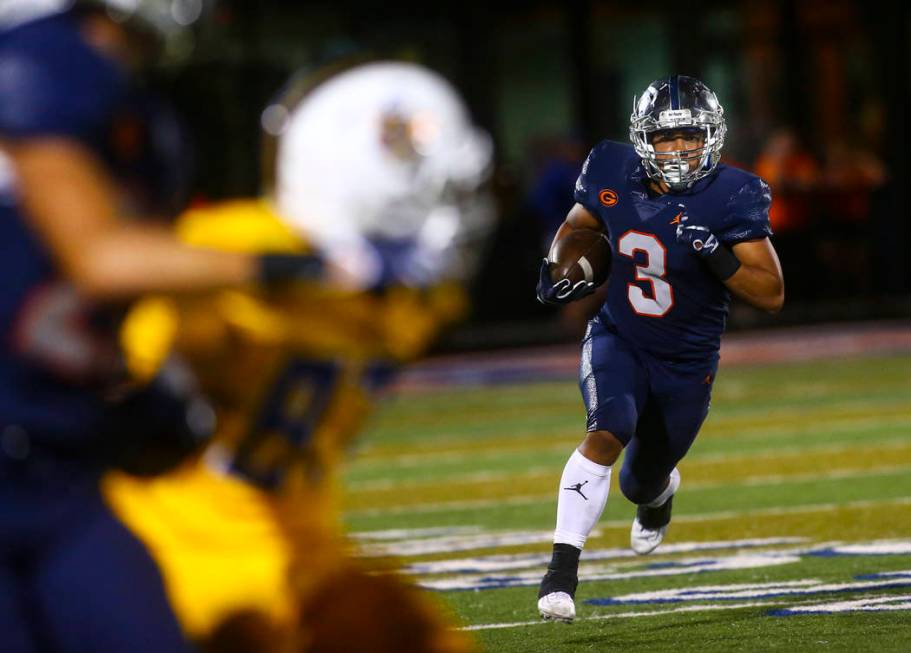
[724,238,784,313]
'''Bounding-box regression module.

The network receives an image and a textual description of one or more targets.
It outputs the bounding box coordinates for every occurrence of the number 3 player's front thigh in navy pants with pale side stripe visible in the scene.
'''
[579,321,647,444]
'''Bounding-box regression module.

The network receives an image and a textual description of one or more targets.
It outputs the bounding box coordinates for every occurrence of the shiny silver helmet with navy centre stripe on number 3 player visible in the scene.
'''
[629,75,727,192]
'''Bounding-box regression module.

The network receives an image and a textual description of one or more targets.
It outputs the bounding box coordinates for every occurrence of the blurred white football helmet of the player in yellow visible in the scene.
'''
[262,62,492,281]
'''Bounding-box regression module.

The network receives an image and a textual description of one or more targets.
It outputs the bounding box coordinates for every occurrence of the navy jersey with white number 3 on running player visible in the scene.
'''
[575,141,772,361]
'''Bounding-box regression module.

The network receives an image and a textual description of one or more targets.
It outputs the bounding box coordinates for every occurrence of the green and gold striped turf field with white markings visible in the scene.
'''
[346,355,911,653]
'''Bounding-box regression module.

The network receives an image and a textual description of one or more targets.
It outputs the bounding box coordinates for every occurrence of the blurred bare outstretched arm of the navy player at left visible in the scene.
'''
[2,138,320,300]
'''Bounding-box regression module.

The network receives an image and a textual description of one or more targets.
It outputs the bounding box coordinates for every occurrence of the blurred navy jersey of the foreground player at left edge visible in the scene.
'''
[0,14,127,442]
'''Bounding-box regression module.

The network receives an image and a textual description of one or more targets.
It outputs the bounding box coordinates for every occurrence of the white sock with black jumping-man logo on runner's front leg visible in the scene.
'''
[554,449,611,549]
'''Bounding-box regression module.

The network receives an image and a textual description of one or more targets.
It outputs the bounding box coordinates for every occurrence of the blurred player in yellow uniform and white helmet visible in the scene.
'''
[103,63,491,652]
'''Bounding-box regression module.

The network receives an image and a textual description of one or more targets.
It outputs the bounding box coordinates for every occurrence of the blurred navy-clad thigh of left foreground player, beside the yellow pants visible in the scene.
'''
[32,497,190,653]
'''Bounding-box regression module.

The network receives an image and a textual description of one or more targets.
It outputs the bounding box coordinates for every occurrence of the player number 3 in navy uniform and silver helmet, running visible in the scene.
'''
[538,75,784,622]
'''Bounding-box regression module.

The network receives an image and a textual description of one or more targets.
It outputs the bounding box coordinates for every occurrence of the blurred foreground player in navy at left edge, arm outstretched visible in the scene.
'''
[0,0,330,653]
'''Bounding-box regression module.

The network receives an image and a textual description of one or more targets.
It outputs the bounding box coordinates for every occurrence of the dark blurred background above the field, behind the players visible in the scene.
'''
[146,0,911,347]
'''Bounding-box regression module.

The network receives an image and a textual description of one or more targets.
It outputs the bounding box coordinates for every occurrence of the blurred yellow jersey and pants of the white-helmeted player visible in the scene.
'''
[103,200,470,651]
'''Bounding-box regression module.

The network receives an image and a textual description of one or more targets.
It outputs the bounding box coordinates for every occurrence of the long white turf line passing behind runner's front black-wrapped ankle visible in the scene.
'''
[402,537,806,574]
